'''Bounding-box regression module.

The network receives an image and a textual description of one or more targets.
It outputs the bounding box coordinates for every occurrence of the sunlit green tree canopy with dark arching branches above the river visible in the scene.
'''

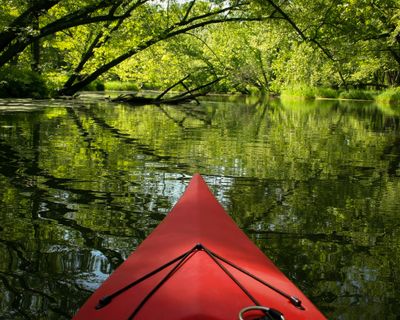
[0,0,400,95]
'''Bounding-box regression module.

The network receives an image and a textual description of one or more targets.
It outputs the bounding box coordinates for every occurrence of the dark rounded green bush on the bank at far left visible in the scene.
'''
[0,67,49,98]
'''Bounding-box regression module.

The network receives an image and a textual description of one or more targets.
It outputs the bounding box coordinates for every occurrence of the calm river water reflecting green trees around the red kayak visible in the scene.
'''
[0,96,400,320]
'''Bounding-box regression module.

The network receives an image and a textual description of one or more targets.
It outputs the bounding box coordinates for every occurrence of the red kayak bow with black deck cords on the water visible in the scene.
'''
[74,175,326,320]
